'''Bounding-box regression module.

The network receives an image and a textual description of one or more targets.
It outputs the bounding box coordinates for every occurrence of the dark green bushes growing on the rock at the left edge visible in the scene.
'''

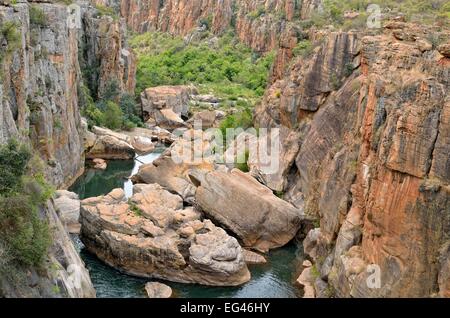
[0,140,54,278]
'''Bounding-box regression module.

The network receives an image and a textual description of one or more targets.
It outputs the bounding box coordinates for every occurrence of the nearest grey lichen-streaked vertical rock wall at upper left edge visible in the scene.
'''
[0,2,84,187]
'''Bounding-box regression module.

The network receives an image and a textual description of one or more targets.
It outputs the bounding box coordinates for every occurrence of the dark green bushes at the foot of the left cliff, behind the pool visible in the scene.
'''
[80,80,143,130]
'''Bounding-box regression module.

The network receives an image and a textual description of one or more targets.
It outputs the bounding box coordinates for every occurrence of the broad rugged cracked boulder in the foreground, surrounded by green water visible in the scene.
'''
[80,184,250,286]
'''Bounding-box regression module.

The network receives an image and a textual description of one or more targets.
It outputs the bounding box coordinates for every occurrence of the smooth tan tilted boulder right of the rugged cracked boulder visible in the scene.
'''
[191,169,303,252]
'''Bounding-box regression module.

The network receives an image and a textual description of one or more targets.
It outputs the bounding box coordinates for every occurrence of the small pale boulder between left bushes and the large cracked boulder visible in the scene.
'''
[54,190,81,234]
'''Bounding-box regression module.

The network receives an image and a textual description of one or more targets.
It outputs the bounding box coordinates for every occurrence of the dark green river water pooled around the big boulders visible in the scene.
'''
[70,150,303,298]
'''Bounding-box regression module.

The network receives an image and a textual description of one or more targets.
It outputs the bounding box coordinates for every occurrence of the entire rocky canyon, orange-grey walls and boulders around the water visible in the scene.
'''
[0,0,450,298]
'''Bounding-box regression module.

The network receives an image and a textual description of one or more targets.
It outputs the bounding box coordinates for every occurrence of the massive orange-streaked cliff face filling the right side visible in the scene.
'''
[256,22,450,297]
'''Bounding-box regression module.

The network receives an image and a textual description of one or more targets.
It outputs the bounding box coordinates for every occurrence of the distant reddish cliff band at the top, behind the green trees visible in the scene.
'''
[94,0,322,80]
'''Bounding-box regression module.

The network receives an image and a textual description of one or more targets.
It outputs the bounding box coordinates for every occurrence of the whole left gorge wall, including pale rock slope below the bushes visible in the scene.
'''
[0,0,135,297]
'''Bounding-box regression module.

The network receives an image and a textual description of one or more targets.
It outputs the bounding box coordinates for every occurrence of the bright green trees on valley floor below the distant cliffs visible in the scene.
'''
[131,32,273,103]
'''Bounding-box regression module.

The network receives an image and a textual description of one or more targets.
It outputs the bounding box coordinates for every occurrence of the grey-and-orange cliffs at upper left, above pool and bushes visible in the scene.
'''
[0,1,136,187]
